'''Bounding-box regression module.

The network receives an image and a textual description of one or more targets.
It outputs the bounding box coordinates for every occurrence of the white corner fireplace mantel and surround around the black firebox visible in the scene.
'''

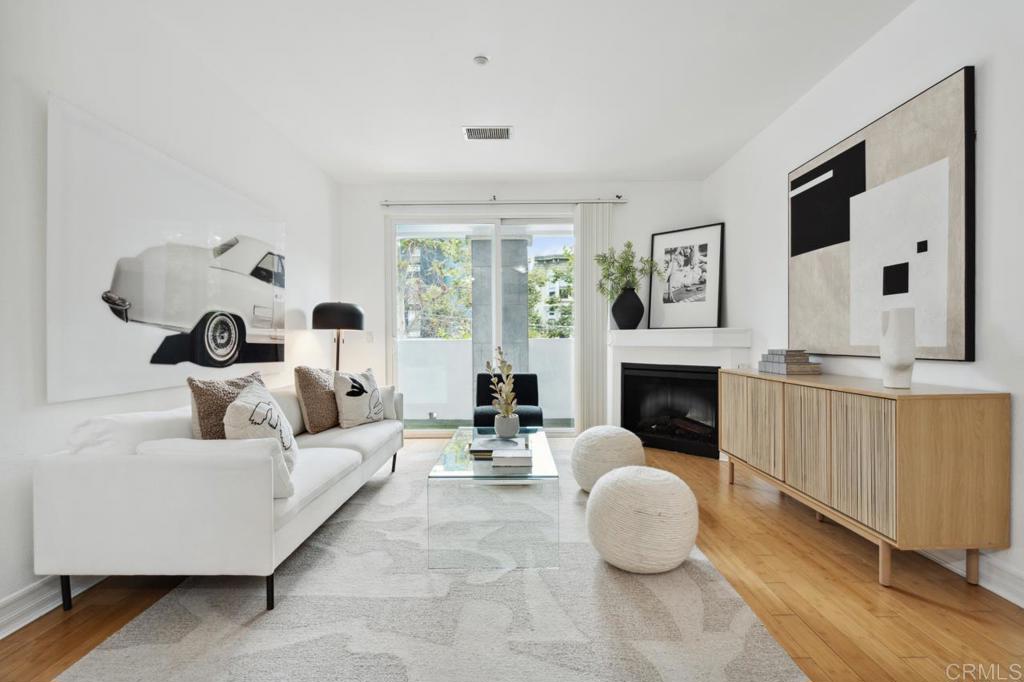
[607,327,751,436]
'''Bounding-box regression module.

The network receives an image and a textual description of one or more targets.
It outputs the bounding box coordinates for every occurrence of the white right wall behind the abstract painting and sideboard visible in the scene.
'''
[705,0,1024,603]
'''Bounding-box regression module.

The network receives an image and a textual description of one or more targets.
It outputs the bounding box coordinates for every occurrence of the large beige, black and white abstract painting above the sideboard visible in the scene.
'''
[788,67,975,360]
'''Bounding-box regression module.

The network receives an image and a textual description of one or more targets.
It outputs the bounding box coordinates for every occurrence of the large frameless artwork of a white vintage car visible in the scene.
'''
[46,97,285,401]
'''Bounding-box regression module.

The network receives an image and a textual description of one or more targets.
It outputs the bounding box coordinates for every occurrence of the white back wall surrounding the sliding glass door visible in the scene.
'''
[336,181,709,369]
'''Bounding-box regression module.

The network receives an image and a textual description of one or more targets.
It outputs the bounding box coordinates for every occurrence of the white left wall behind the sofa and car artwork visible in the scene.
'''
[0,0,338,616]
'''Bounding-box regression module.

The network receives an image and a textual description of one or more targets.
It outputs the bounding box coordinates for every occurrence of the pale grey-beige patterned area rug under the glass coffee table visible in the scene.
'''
[58,440,805,682]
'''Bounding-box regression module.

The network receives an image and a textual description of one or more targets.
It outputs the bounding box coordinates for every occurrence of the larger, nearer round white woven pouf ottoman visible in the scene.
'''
[587,467,698,573]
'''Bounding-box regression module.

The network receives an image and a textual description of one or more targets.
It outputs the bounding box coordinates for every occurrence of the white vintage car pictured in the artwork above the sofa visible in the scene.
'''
[101,235,285,367]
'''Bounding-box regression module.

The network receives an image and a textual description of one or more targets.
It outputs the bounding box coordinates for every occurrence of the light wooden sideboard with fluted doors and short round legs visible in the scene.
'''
[718,370,1010,586]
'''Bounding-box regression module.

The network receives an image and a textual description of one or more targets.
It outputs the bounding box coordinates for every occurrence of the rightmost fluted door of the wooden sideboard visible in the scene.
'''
[829,392,896,538]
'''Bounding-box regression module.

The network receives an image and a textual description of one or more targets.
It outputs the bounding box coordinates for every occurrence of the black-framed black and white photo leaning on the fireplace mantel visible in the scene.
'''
[647,222,725,329]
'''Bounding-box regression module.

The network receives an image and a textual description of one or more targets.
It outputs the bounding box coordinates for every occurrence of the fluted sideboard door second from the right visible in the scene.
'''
[783,384,831,504]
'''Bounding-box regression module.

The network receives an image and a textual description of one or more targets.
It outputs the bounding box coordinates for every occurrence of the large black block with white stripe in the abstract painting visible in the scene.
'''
[790,142,866,256]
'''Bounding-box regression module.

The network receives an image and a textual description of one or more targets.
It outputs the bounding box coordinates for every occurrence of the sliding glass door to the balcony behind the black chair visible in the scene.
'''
[391,220,574,430]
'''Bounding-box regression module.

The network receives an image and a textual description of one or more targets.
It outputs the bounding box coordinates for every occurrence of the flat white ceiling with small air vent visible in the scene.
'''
[151,0,909,182]
